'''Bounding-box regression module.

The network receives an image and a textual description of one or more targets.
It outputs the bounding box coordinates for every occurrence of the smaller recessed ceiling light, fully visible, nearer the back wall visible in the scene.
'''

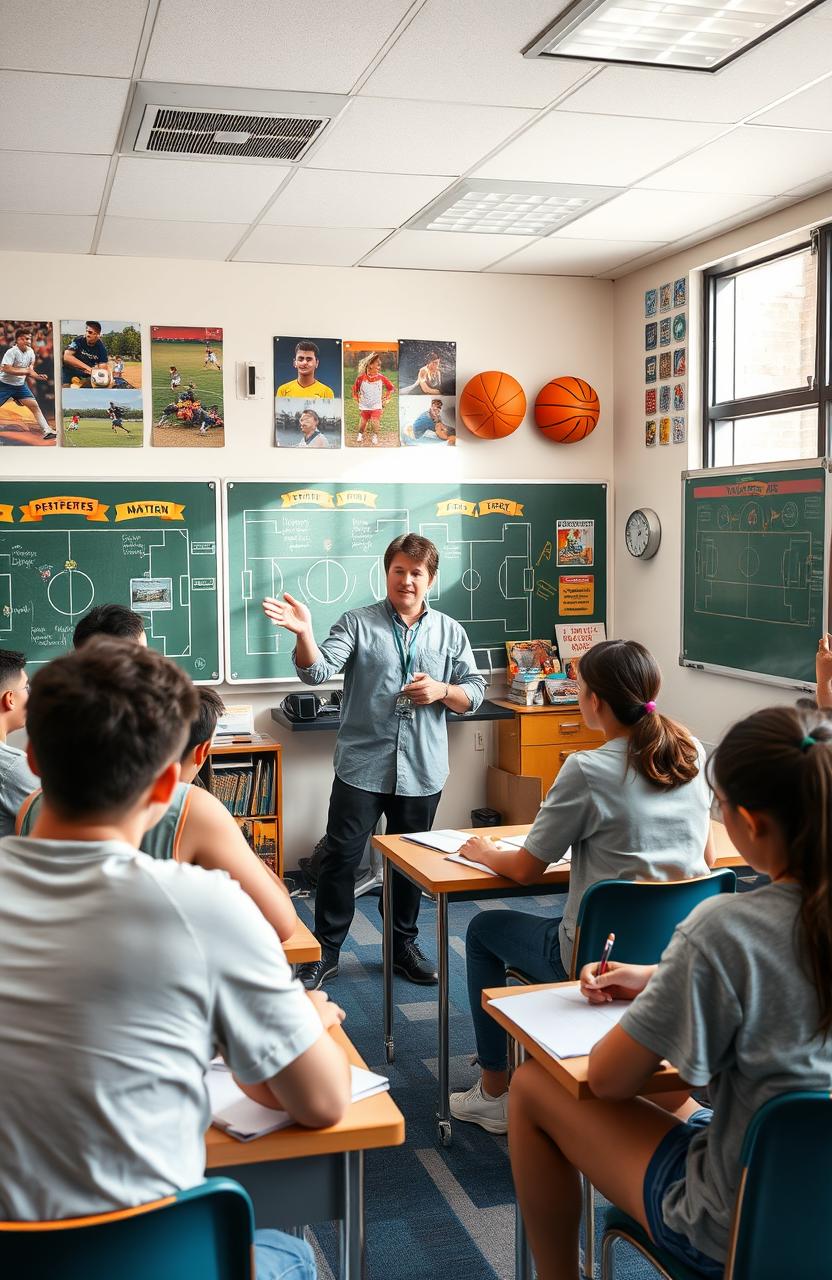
[407,178,621,236]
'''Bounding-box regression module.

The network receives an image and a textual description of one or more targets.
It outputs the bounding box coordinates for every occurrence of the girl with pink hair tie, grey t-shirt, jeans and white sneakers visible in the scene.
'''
[451,640,713,1133]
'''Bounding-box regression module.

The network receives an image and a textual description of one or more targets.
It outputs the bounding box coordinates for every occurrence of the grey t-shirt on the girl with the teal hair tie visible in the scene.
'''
[620,881,832,1260]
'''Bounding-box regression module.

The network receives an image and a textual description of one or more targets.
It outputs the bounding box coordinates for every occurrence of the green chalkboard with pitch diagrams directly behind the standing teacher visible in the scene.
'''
[224,480,607,682]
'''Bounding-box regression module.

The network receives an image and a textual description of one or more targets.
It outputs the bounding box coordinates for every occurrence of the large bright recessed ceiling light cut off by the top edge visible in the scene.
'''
[524,0,823,72]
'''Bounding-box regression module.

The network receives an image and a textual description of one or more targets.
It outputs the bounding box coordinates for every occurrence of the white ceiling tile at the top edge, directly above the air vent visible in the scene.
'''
[143,0,411,93]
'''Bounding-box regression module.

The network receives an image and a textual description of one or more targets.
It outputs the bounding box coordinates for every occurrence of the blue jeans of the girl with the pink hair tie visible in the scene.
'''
[465,896,568,1071]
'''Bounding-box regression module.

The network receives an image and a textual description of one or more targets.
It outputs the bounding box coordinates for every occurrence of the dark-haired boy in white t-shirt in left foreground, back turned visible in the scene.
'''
[0,637,349,1280]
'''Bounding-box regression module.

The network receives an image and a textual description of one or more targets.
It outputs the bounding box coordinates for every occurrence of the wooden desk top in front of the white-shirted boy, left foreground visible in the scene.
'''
[205,1027,404,1170]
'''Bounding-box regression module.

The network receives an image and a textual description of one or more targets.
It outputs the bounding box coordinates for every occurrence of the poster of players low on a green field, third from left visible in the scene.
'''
[150,325,225,449]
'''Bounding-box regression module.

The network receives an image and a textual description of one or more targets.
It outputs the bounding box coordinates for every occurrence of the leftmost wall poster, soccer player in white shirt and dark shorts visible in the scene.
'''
[0,320,56,448]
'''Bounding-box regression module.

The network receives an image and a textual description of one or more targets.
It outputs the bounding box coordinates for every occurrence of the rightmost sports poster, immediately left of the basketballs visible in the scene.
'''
[398,338,457,445]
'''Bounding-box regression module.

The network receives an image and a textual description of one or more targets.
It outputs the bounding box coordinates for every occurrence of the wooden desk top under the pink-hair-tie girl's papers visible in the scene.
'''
[372,822,745,893]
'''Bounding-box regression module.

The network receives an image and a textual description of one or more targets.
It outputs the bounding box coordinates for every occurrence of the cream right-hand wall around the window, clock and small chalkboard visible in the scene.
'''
[613,192,832,742]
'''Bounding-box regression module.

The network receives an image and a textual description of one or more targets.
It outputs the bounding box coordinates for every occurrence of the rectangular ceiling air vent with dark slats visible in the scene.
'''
[134,104,329,160]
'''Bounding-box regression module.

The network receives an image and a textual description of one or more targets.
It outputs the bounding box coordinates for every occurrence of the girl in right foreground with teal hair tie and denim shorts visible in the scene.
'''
[509,707,832,1280]
